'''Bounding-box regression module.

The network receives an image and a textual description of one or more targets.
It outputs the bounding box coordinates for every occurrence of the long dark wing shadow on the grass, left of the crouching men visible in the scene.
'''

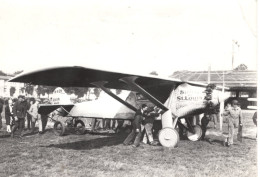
[40,134,127,150]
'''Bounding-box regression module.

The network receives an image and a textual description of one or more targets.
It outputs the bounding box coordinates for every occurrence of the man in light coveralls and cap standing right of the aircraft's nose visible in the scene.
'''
[223,100,243,147]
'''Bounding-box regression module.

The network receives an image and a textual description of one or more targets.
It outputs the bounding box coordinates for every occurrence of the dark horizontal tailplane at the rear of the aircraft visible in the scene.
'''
[38,104,74,115]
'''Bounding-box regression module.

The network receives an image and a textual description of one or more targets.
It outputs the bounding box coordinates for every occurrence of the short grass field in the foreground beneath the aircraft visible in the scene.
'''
[0,112,257,177]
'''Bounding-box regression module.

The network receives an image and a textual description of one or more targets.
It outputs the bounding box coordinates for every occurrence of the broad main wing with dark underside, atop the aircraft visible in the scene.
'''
[9,66,206,102]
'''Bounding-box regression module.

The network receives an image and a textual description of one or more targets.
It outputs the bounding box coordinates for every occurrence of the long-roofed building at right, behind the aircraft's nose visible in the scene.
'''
[171,70,257,109]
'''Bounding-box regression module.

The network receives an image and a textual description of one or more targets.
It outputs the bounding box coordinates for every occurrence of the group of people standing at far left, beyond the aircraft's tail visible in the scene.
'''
[0,95,43,138]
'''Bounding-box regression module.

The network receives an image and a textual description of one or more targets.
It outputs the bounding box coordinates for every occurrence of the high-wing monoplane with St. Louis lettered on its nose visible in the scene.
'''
[9,66,229,147]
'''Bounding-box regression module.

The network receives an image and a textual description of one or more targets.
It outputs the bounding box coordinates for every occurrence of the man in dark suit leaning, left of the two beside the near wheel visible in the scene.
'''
[123,104,148,147]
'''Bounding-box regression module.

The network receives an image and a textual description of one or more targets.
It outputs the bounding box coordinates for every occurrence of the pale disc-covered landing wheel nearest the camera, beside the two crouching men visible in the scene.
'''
[159,127,180,147]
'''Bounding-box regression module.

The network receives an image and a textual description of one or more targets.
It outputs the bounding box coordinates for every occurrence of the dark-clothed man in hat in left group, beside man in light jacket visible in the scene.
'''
[11,95,27,137]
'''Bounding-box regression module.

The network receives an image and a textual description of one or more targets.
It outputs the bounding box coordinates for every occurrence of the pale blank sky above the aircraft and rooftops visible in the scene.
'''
[0,0,257,76]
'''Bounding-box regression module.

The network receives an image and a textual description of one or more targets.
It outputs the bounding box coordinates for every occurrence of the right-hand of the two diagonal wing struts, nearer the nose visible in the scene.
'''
[120,76,168,111]
